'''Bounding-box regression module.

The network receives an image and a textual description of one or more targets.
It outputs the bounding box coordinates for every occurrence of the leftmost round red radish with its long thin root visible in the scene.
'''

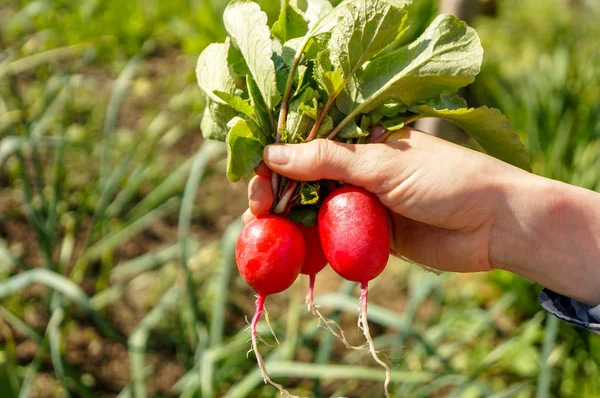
[235,215,306,397]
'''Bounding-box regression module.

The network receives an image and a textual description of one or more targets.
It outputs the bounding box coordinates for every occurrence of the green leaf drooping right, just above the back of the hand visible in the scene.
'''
[417,99,531,170]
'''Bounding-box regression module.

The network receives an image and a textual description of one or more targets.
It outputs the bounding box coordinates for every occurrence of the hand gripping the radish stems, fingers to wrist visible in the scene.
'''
[244,129,527,272]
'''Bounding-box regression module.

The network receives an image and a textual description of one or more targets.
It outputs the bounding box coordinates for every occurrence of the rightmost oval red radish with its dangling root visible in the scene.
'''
[318,185,391,397]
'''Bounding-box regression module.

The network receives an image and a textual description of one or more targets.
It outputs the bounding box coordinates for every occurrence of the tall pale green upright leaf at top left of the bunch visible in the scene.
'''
[223,0,281,110]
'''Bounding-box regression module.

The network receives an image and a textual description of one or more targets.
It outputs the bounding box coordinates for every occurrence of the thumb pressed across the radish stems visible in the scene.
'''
[263,139,381,187]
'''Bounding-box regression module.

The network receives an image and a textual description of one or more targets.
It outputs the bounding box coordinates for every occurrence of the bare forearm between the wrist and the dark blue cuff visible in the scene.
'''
[490,175,600,306]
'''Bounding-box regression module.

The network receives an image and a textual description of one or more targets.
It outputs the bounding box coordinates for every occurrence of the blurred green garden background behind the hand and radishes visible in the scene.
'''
[0,0,600,398]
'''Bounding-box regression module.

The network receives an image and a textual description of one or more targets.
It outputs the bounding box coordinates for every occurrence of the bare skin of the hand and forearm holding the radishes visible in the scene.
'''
[243,128,600,306]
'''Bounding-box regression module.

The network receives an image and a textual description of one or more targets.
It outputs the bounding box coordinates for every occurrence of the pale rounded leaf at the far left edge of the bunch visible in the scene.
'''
[196,39,235,104]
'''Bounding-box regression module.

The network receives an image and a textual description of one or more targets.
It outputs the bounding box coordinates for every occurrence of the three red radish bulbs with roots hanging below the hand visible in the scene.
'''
[236,185,390,396]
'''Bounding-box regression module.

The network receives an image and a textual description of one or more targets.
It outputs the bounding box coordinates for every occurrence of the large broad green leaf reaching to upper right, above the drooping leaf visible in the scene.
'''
[337,15,483,116]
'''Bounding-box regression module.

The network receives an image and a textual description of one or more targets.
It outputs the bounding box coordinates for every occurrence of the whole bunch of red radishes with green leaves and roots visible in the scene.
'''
[196,0,529,396]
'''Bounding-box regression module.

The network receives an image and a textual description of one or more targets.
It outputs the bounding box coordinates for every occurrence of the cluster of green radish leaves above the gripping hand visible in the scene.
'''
[197,0,529,182]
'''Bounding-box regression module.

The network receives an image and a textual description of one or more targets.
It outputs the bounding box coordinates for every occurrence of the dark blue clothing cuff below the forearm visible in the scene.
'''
[540,289,600,334]
